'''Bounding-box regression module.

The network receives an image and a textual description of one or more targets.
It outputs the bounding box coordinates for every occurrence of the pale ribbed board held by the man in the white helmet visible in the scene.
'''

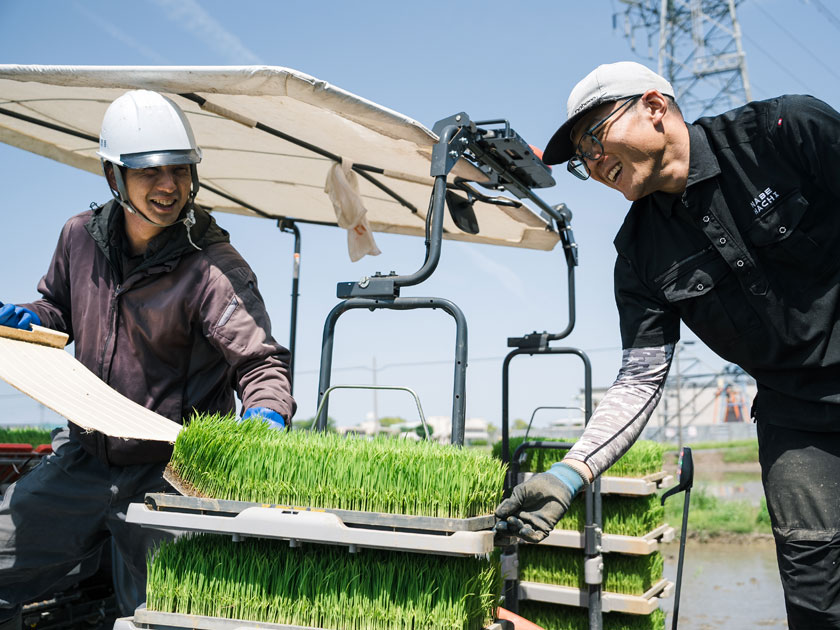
[0,326,181,442]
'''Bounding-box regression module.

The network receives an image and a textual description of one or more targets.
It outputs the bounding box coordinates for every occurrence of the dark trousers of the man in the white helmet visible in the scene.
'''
[0,429,172,621]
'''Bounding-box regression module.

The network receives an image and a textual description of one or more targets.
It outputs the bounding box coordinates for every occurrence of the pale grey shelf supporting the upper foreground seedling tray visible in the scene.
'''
[126,503,494,556]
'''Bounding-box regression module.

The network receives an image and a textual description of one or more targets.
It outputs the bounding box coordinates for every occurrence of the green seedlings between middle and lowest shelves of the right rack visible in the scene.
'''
[519,545,664,595]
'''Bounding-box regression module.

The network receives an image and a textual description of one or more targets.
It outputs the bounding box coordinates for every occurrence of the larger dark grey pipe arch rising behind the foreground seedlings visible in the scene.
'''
[316,297,467,445]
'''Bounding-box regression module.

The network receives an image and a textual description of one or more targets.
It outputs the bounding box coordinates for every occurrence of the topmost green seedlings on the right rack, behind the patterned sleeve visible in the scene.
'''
[493,437,665,477]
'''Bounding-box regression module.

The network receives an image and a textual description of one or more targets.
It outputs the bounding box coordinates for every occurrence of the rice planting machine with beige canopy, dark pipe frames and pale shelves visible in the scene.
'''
[0,65,688,630]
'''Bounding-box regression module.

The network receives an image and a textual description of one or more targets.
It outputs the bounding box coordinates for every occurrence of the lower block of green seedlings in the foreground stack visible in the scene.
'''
[146,534,501,630]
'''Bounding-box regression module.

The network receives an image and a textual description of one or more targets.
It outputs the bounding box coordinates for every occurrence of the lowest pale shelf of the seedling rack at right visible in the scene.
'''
[519,579,674,615]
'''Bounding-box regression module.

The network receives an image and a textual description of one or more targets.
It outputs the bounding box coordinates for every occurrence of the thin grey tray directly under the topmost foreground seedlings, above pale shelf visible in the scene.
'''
[145,493,496,533]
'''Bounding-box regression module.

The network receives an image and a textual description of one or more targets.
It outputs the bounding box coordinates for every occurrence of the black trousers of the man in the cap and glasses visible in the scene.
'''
[758,417,840,630]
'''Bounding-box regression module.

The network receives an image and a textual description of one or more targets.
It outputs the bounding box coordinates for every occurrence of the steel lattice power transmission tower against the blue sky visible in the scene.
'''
[613,0,752,120]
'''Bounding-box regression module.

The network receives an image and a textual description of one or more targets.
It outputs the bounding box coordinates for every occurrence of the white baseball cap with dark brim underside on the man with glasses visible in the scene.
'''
[542,61,674,164]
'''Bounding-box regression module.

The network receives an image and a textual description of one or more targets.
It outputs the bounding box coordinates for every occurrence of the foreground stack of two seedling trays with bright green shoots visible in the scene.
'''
[121,417,504,630]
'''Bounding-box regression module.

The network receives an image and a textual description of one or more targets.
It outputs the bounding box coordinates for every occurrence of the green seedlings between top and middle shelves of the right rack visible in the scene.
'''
[556,494,665,536]
